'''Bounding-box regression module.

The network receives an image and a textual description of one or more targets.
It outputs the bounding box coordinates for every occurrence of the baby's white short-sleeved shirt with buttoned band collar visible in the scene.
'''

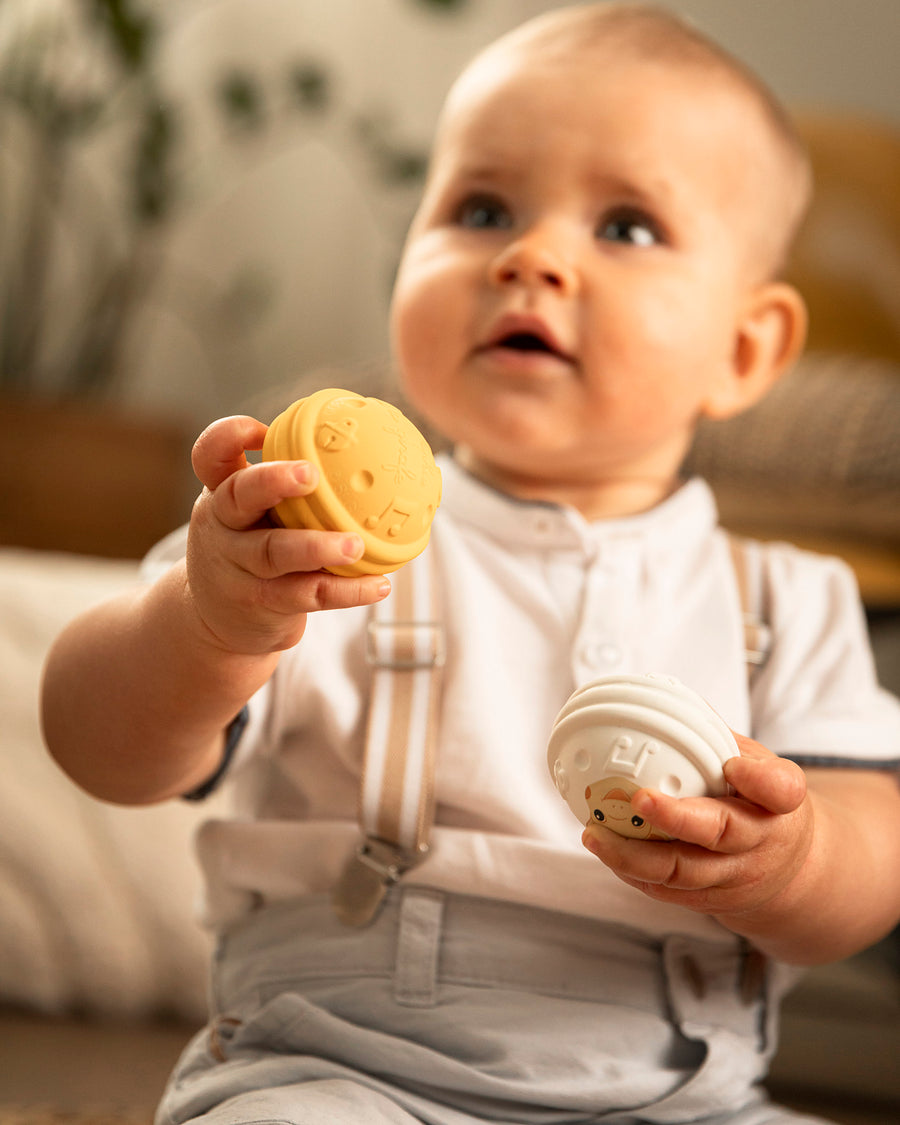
[149,458,900,938]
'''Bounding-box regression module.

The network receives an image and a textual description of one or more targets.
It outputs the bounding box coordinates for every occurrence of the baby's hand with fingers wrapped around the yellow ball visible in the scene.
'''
[187,416,390,655]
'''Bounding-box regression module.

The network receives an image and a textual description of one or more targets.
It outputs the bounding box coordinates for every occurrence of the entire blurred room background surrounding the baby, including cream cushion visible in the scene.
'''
[0,0,900,1125]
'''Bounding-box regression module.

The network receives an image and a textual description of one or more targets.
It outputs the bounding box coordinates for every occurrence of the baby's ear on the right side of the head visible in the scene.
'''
[703,281,807,419]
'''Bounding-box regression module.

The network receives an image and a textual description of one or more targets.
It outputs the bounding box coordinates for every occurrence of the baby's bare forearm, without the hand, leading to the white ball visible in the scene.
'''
[719,770,900,964]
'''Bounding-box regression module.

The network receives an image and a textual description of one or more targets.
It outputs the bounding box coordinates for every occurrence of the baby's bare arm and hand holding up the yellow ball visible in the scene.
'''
[42,417,390,804]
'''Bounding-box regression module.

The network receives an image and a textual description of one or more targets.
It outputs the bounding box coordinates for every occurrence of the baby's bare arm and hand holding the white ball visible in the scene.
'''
[584,738,900,964]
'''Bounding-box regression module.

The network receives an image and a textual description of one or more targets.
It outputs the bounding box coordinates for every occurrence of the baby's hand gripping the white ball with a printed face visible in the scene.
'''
[582,735,813,915]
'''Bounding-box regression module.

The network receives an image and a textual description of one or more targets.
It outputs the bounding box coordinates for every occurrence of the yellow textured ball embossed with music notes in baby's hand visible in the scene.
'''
[262,387,441,575]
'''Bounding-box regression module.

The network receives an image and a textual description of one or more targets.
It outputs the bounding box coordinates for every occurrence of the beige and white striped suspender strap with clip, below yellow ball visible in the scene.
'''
[334,550,444,926]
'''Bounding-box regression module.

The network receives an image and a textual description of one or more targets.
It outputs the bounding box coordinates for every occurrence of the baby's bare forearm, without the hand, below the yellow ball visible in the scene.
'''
[42,565,278,804]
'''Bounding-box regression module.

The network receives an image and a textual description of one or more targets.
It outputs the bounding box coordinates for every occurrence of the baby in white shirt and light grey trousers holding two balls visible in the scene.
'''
[44,3,900,1125]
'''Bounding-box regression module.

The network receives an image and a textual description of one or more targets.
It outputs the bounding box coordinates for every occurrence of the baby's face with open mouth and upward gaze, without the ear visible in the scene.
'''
[393,46,778,514]
